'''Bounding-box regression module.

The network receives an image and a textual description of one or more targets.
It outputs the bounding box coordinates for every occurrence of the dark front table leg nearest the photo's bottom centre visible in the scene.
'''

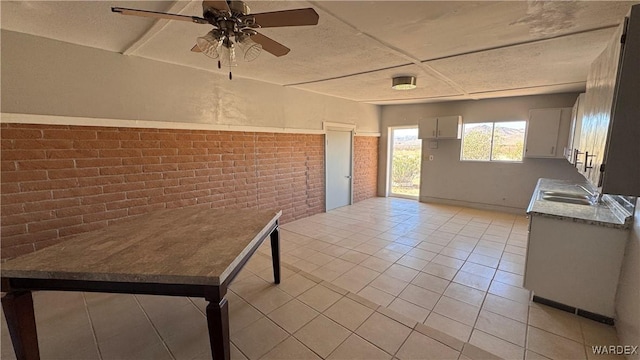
[207,297,231,360]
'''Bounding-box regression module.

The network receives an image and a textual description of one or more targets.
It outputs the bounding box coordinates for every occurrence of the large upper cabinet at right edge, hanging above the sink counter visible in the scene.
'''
[576,5,640,196]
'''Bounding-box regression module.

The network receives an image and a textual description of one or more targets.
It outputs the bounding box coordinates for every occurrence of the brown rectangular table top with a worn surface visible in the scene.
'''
[0,207,282,285]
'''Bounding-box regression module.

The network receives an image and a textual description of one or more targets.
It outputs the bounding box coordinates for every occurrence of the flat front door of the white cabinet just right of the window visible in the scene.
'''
[525,109,562,158]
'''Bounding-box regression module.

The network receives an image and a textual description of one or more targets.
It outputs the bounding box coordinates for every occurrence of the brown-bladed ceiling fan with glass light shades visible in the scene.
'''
[111,0,318,79]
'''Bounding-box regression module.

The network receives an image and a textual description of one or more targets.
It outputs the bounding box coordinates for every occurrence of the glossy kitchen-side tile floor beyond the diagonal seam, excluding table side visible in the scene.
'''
[274,198,617,359]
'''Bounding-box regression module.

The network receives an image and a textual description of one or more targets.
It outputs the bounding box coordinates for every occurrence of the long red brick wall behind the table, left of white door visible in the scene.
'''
[0,124,324,259]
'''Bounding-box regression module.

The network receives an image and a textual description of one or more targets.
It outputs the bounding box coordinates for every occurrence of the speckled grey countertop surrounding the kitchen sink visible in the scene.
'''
[527,179,633,229]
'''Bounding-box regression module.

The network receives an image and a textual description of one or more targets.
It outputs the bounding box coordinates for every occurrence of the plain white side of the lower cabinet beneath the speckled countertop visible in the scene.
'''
[524,215,628,318]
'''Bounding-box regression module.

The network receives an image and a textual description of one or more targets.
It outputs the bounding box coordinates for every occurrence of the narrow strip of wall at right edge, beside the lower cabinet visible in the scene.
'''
[616,200,640,360]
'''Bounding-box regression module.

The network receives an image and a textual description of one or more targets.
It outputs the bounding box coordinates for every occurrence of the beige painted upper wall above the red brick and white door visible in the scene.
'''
[1,30,380,133]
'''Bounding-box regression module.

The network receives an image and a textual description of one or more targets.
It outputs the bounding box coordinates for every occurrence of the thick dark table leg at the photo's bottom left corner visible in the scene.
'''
[2,291,40,360]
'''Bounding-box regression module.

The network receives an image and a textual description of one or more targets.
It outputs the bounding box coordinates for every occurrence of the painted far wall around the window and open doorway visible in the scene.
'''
[378,94,584,212]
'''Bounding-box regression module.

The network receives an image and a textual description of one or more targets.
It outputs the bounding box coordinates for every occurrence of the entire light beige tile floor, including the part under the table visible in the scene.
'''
[0,198,618,359]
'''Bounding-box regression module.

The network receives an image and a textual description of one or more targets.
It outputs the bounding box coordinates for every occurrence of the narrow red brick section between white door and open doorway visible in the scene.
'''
[353,136,379,202]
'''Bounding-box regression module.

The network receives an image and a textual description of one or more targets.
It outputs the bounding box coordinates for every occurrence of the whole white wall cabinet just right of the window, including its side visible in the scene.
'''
[525,108,572,158]
